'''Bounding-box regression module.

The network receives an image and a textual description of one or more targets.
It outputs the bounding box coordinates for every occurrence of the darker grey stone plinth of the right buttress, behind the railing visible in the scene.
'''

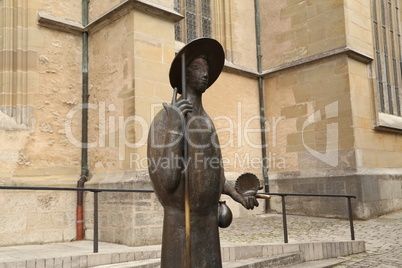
[271,174,402,219]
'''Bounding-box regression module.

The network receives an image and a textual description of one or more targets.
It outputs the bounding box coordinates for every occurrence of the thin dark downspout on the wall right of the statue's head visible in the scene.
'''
[254,0,270,213]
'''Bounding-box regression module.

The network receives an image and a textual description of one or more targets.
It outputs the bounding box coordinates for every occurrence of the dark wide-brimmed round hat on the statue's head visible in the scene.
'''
[169,37,225,94]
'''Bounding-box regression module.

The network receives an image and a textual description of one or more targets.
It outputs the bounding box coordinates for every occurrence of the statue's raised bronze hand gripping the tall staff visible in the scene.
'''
[163,88,193,130]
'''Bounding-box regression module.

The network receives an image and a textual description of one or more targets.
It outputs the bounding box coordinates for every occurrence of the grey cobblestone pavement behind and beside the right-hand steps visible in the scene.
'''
[220,211,402,268]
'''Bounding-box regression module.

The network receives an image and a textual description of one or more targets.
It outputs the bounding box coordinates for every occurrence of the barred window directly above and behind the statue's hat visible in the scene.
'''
[174,0,212,43]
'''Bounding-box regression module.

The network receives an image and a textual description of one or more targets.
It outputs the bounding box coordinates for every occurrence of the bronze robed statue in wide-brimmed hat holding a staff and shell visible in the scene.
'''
[148,38,258,268]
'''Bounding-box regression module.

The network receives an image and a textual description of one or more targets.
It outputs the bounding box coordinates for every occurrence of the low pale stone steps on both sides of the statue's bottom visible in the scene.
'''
[0,241,365,268]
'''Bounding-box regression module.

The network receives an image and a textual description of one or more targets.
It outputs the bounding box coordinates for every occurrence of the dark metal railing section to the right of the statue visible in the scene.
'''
[265,193,356,243]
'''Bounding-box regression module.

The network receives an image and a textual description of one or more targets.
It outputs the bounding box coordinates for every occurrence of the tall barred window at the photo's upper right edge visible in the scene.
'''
[372,0,402,116]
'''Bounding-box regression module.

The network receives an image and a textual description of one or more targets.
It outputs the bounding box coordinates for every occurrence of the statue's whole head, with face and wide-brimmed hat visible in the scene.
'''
[169,38,225,94]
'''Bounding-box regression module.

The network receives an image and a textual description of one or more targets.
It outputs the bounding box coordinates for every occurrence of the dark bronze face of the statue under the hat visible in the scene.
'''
[186,58,209,93]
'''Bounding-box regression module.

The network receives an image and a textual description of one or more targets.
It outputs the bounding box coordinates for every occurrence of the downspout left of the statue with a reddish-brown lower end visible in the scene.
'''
[76,0,90,240]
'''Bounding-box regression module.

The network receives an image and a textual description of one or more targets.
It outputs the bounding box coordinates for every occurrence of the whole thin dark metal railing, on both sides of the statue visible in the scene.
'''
[0,186,356,253]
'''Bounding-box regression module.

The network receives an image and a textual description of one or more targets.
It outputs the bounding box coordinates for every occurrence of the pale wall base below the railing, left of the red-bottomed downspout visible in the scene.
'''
[0,190,76,246]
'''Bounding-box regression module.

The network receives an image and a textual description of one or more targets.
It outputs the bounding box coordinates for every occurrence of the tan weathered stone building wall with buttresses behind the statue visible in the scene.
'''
[0,0,402,249]
